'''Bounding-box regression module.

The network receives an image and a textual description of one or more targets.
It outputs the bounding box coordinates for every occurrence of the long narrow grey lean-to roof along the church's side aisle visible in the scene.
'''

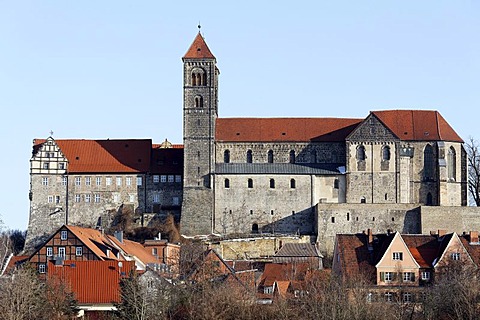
[215,163,344,175]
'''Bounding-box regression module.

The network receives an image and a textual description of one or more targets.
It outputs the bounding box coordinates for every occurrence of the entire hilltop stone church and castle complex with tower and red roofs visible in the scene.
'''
[23,32,467,250]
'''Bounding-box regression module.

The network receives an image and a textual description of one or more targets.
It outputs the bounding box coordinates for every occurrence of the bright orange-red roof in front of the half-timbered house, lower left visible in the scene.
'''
[47,261,135,304]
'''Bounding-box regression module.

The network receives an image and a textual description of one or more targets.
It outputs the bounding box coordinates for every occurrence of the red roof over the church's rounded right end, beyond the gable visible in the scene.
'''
[372,110,463,142]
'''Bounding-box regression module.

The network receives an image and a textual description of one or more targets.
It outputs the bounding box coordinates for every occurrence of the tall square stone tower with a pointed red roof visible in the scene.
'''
[181,32,219,235]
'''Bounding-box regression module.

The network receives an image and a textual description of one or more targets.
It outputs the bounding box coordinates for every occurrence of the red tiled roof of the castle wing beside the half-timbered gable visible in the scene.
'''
[34,139,152,173]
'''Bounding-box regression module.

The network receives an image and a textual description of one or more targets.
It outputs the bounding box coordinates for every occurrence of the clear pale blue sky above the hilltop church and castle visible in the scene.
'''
[0,0,480,230]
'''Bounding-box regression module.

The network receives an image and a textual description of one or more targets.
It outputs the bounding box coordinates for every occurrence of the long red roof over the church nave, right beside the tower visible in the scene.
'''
[215,118,362,142]
